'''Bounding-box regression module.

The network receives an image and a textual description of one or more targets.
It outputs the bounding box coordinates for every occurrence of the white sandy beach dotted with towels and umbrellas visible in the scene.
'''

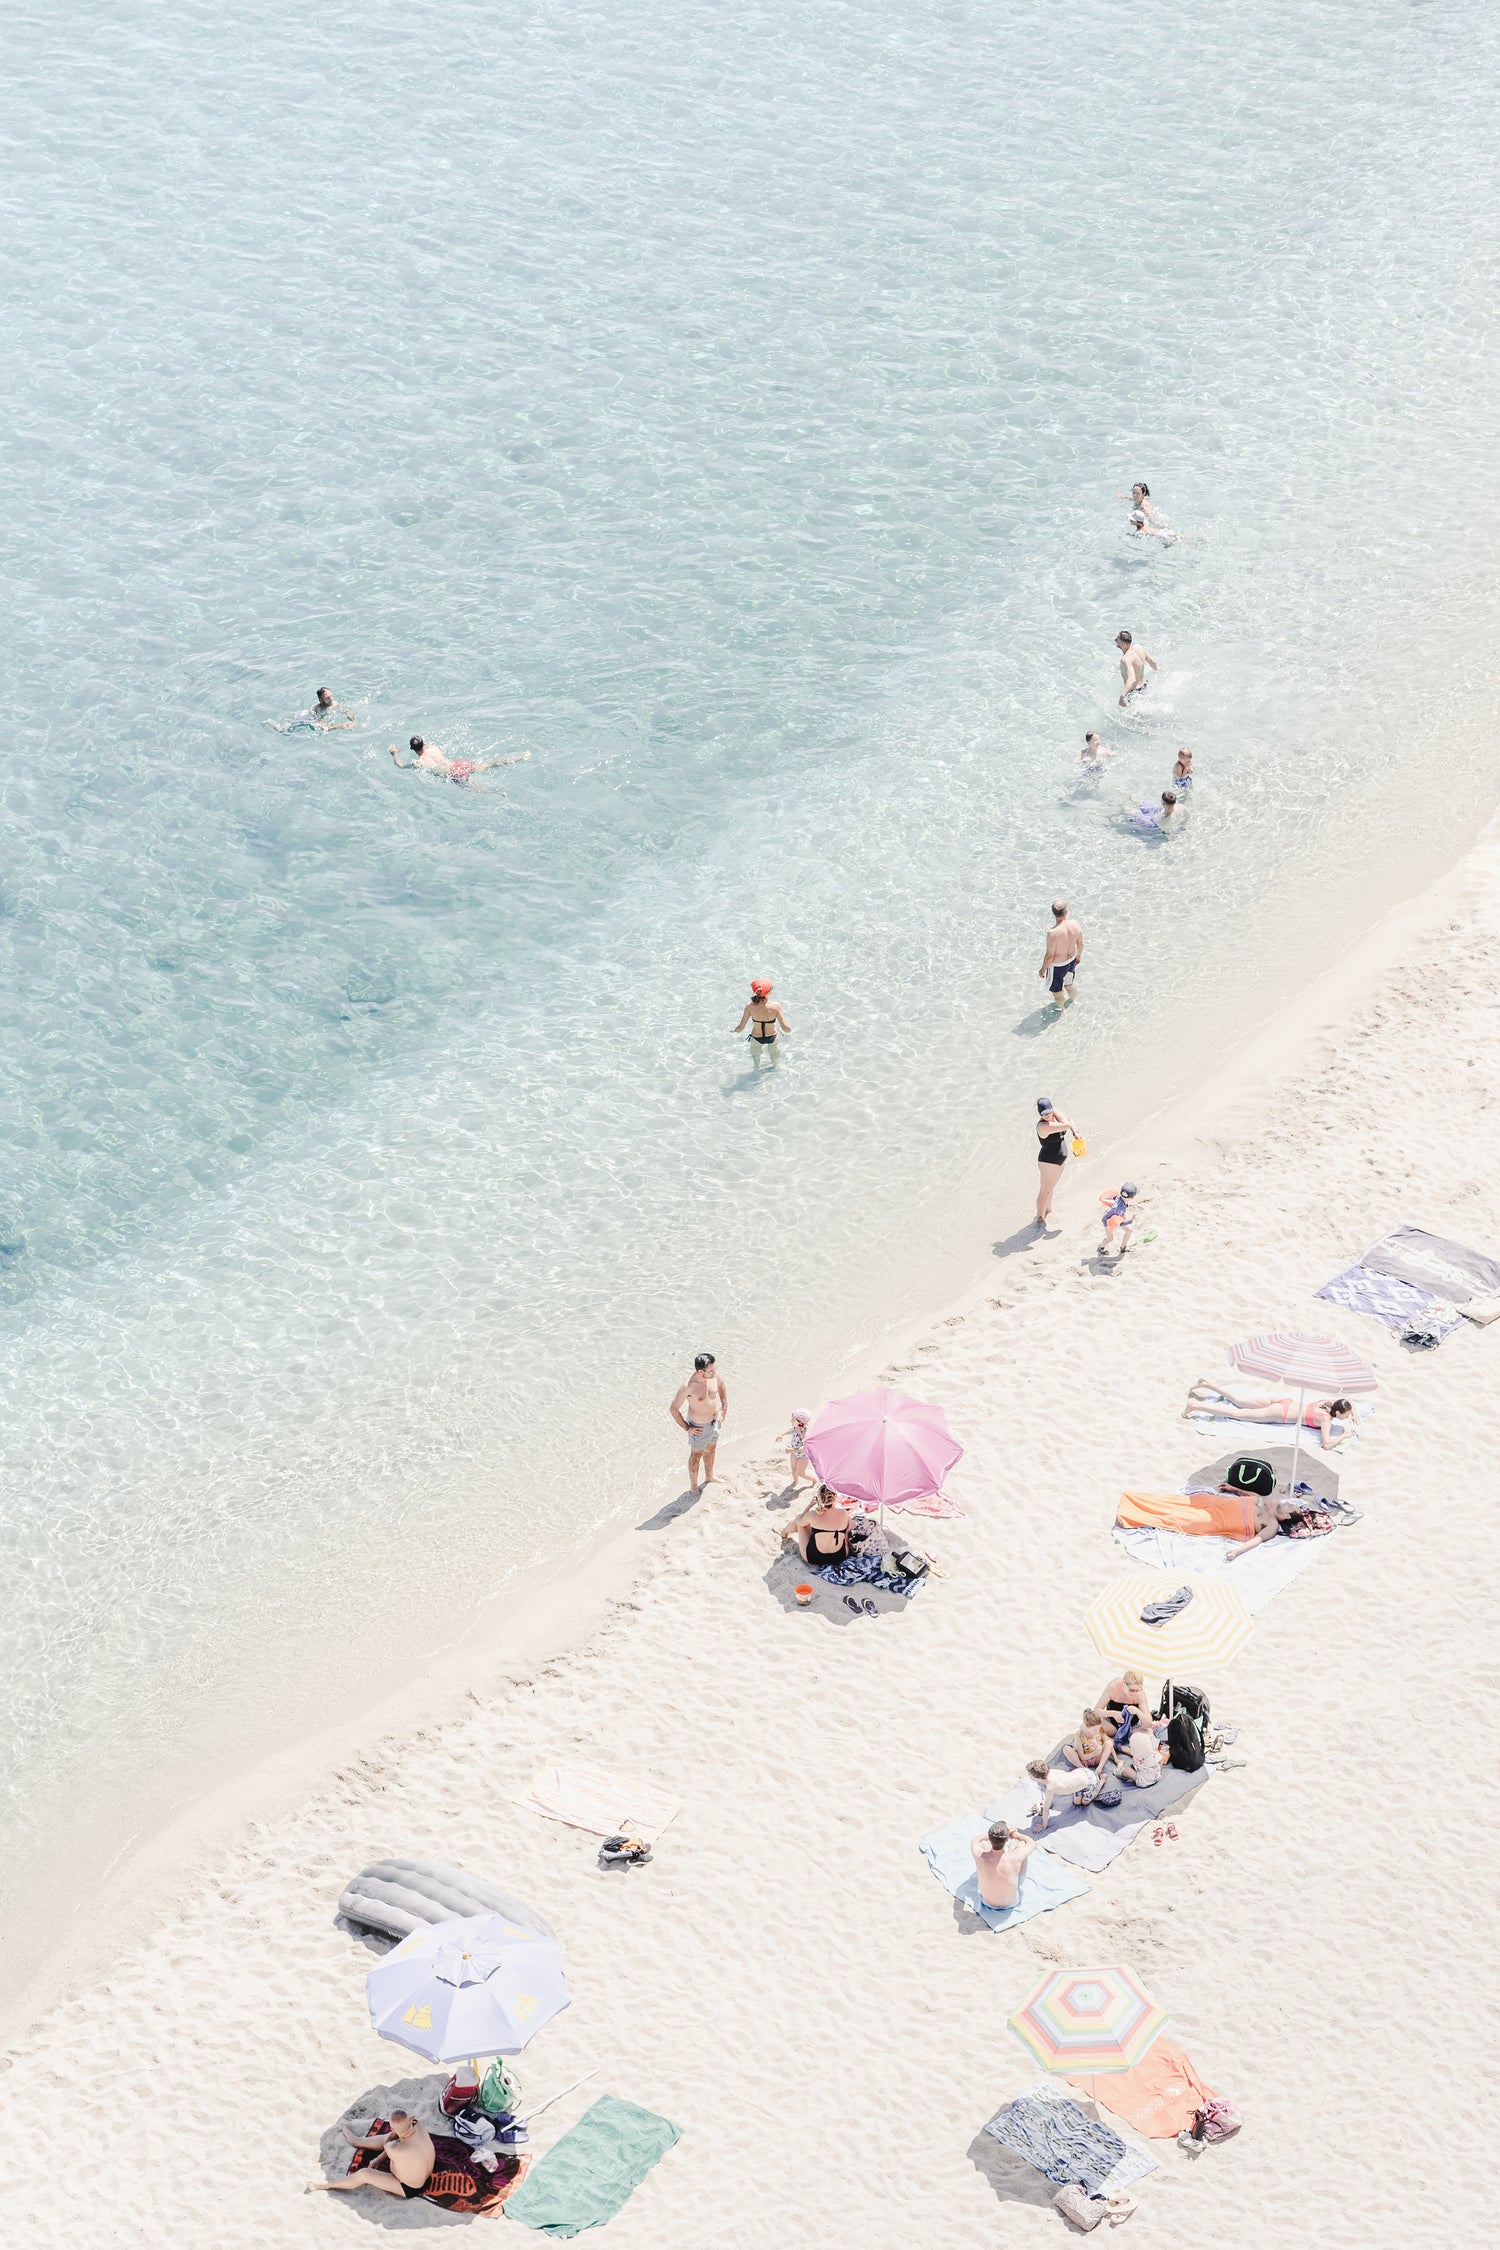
[0,844,1500,2250]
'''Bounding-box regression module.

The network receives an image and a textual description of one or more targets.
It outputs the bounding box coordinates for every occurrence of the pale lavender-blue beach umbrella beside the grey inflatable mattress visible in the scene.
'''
[364,1915,569,2063]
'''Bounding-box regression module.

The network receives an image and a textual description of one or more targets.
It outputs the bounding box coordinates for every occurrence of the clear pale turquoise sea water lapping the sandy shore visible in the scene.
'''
[0,0,1500,1960]
